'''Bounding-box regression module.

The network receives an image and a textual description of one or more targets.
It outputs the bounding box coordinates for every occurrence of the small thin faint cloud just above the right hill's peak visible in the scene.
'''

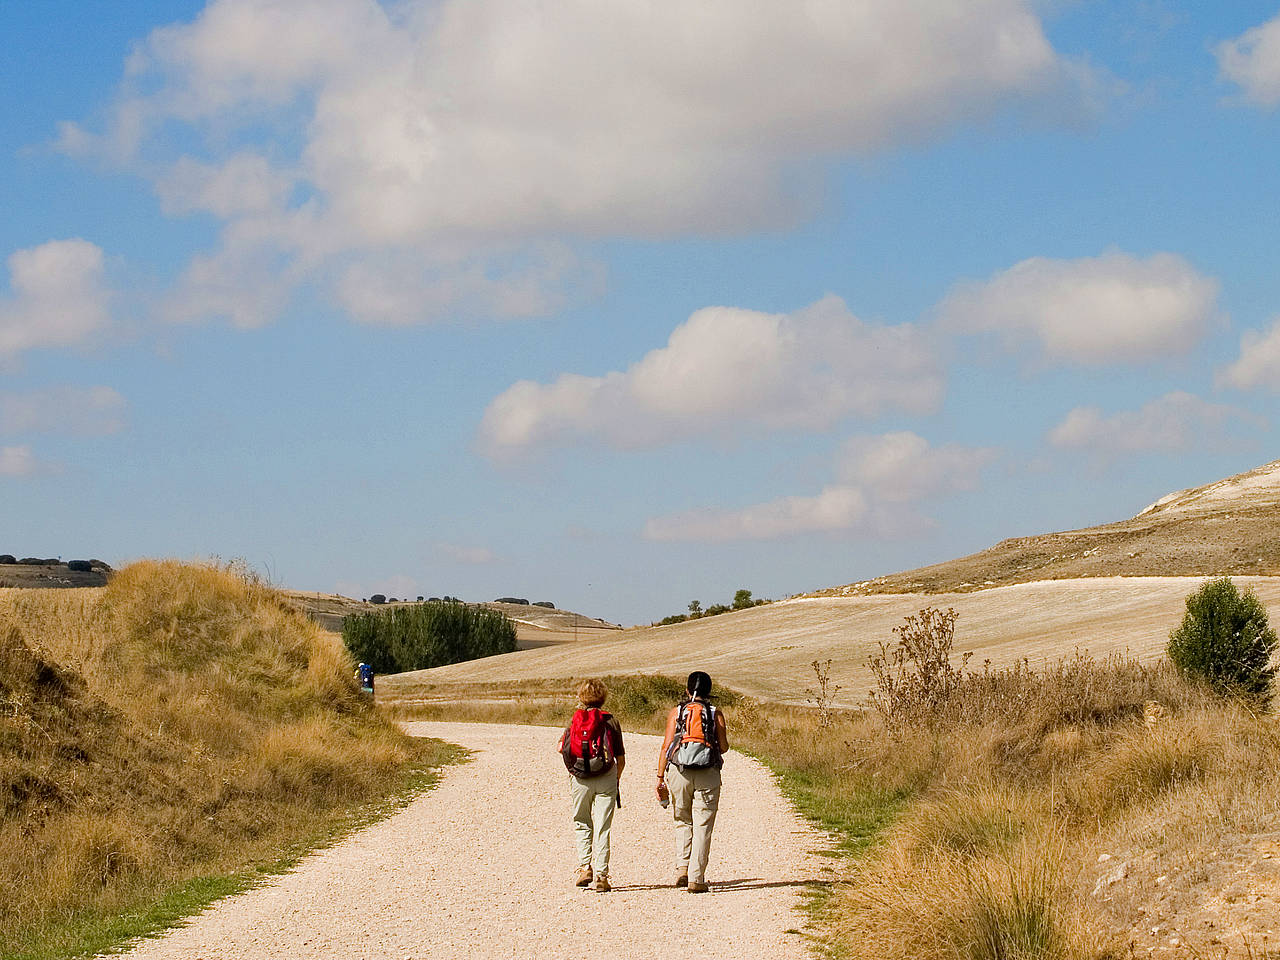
[1048,390,1258,456]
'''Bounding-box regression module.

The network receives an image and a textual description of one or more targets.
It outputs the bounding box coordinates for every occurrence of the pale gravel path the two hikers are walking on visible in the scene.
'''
[115,723,831,960]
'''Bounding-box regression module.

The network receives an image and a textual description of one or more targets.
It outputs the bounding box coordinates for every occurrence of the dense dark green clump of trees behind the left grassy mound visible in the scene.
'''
[342,600,516,673]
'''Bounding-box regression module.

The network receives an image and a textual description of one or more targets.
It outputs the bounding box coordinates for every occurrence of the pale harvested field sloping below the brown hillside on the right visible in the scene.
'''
[383,577,1280,705]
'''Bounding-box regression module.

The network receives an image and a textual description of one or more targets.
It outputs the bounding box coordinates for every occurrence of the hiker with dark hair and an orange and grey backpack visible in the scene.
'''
[658,669,728,893]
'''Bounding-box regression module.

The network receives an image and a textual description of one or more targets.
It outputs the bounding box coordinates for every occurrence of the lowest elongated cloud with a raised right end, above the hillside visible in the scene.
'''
[644,431,997,541]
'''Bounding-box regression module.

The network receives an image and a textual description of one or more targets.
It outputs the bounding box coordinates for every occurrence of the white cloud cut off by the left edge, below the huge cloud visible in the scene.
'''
[0,239,110,361]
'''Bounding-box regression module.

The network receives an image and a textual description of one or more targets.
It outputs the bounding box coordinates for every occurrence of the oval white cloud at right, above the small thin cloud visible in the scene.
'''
[937,251,1219,365]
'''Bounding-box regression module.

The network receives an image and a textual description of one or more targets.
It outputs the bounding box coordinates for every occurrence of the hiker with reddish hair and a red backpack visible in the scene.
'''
[559,680,627,893]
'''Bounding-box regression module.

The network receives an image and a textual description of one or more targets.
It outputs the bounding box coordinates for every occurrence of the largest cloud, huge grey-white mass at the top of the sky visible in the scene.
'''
[61,0,1088,325]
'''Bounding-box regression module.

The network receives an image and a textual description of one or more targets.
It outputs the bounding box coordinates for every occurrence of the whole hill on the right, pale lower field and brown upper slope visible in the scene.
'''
[381,461,1280,705]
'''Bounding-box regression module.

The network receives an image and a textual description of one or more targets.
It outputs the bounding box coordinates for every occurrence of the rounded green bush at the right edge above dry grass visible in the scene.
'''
[1169,577,1276,700]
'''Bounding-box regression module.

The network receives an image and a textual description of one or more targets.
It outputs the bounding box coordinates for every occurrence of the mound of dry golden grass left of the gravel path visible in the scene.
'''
[0,562,455,955]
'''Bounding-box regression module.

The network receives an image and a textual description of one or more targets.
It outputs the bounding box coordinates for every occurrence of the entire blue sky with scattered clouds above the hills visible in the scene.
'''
[0,0,1280,623]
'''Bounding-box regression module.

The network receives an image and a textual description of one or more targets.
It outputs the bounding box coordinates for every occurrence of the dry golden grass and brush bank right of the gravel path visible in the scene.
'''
[829,654,1280,960]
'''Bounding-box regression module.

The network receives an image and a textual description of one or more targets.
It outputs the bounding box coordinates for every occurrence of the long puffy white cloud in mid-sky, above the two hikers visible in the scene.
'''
[477,297,943,458]
